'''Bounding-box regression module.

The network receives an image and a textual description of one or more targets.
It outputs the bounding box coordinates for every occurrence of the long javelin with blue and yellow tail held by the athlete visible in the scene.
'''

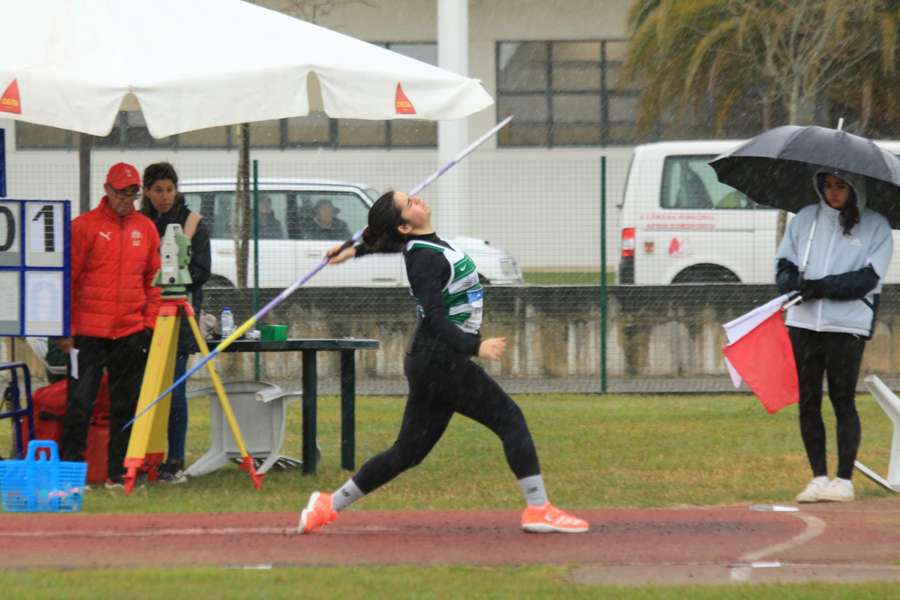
[122,115,512,431]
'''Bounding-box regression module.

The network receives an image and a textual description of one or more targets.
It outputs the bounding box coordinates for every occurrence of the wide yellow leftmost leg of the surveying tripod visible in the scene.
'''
[125,306,178,494]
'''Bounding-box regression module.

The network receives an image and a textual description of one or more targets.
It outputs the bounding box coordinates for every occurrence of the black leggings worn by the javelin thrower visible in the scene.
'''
[353,344,541,494]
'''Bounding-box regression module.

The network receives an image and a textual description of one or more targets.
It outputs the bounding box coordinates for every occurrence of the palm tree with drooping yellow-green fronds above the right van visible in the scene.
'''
[623,0,884,131]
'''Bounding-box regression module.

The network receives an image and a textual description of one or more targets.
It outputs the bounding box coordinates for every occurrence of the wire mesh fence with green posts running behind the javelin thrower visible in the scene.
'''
[7,149,900,404]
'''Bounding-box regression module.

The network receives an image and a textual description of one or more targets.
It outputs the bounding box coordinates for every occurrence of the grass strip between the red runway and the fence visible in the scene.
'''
[10,395,890,513]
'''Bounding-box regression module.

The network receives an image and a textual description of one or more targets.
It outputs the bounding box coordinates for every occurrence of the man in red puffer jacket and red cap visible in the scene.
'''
[60,163,159,487]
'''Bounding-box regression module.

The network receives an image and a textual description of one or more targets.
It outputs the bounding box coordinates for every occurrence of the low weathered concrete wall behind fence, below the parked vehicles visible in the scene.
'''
[14,284,900,384]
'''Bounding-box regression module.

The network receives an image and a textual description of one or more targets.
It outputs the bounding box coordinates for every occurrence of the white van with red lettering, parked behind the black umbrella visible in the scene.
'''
[618,140,900,285]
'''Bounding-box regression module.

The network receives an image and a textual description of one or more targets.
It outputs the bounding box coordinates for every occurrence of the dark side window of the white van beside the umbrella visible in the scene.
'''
[659,155,765,210]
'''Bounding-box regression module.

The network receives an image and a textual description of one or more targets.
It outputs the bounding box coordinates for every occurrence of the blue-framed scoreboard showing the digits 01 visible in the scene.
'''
[0,199,71,337]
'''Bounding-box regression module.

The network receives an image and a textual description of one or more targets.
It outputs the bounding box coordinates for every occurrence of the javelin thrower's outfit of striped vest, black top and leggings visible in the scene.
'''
[353,234,540,494]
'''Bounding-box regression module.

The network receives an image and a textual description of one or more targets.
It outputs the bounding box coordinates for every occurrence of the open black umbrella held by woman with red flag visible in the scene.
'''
[709,125,900,229]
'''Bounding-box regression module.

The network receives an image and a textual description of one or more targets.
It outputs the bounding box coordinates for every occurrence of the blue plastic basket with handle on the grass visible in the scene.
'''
[0,440,87,512]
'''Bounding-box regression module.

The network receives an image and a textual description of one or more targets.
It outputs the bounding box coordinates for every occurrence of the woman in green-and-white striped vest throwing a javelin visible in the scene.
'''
[298,191,588,533]
